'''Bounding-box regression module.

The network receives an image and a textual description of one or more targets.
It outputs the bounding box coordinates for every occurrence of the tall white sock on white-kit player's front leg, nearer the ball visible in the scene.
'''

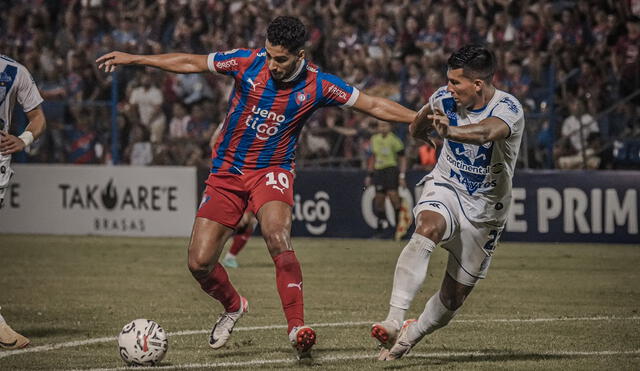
[387,233,436,323]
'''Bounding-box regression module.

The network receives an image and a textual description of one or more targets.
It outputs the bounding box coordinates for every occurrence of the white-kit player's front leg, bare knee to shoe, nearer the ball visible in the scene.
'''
[371,210,446,359]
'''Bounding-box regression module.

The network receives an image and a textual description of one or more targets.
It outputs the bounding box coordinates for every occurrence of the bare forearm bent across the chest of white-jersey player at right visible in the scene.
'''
[427,111,511,145]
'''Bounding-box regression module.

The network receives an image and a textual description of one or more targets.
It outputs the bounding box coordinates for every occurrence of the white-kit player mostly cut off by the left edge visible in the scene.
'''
[0,54,45,349]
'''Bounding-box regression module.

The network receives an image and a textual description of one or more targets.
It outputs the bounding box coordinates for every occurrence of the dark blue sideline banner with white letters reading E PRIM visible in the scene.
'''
[293,170,640,244]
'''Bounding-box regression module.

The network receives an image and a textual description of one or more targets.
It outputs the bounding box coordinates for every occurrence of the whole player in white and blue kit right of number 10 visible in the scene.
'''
[371,45,524,360]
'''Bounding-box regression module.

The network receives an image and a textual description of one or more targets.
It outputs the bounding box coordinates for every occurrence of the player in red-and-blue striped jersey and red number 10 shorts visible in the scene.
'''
[96,16,416,358]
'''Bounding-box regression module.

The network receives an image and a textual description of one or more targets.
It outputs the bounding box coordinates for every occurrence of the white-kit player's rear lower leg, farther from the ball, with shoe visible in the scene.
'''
[385,273,473,360]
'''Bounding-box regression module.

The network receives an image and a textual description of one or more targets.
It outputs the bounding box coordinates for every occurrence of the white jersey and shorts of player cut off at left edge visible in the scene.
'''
[0,54,42,192]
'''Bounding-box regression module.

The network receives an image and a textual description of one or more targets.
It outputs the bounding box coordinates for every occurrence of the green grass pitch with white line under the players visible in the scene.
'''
[0,235,640,370]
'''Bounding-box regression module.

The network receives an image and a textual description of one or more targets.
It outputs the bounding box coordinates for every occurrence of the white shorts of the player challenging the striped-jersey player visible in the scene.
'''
[413,176,504,286]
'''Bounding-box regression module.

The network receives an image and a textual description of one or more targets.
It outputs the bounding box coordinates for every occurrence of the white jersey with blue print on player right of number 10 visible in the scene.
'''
[428,86,524,224]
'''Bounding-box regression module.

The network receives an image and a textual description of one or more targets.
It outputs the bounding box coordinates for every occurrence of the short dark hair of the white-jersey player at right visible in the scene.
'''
[447,45,496,81]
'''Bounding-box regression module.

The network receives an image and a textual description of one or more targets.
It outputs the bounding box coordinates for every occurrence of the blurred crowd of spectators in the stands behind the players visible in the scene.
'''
[5,0,640,171]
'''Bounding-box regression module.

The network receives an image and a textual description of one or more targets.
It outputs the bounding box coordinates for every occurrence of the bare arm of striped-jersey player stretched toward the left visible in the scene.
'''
[96,51,209,73]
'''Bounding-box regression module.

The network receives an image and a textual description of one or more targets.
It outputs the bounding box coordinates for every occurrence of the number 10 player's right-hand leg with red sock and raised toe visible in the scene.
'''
[257,201,316,359]
